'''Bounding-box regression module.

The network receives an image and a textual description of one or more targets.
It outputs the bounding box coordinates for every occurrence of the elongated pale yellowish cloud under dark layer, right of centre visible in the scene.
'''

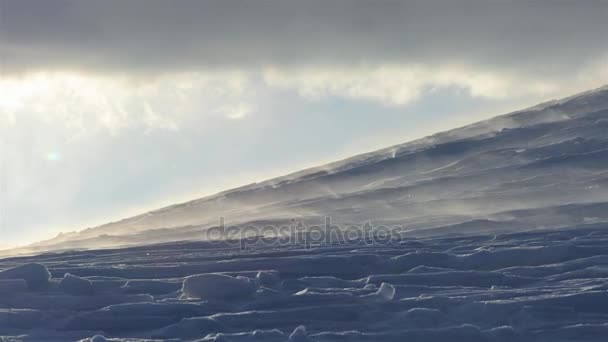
[264,65,558,106]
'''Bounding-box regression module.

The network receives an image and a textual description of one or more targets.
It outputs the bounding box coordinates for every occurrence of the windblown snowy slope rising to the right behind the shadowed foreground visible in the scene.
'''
[11,87,608,250]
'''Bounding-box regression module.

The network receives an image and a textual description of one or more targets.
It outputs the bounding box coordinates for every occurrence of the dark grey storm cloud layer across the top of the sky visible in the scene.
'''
[0,0,608,73]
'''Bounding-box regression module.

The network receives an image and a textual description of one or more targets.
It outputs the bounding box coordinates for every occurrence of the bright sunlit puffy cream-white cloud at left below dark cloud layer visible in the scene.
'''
[0,72,257,138]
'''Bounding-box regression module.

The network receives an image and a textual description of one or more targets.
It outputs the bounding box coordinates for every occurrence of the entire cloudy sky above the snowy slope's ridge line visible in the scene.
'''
[0,0,608,247]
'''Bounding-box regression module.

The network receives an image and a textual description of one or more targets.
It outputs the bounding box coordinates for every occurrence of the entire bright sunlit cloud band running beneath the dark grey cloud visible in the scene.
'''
[0,65,601,135]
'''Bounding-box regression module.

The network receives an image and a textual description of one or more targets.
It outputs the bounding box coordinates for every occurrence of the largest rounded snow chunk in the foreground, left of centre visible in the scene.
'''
[182,273,257,299]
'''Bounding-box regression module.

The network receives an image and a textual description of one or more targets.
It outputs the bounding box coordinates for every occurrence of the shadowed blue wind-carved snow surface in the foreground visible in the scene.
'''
[0,224,608,342]
